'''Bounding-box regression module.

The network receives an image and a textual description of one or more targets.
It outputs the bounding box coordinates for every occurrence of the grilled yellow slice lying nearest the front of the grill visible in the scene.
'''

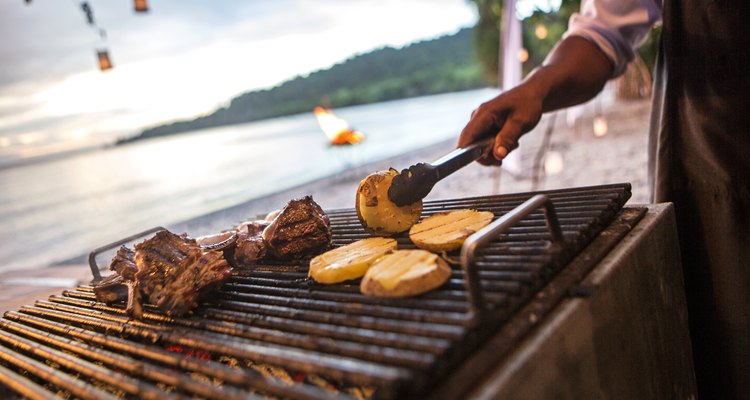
[359,250,451,297]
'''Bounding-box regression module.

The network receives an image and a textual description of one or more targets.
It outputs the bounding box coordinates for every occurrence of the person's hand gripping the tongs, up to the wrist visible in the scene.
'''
[458,82,543,165]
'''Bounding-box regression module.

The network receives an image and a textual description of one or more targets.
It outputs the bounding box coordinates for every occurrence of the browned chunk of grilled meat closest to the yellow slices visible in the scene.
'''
[263,196,331,260]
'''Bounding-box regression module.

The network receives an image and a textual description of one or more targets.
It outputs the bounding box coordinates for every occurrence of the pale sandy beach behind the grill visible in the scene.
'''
[0,94,650,311]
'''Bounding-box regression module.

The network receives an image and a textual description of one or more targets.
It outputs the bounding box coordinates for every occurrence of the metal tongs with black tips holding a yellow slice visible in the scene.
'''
[388,136,495,207]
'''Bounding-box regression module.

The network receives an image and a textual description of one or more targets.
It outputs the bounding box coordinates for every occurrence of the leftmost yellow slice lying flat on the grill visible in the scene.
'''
[310,237,397,283]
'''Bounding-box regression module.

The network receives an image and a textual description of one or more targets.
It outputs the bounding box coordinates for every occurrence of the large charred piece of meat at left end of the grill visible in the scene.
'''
[135,230,231,316]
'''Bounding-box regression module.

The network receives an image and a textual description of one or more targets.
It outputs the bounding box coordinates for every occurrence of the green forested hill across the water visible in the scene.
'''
[118,28,487,144]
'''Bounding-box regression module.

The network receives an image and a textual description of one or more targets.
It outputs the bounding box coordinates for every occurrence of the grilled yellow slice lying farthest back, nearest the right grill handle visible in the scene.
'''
[409,210,495,253]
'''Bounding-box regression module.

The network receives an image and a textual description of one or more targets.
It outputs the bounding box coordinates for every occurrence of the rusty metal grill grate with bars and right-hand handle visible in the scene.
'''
[0,184,645,399]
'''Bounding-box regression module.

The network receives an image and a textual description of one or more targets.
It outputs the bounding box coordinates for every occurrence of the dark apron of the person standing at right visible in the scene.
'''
[649,0,750,399]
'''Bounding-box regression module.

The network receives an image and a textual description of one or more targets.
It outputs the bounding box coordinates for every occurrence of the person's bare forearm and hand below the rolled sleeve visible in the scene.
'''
[458,36,614,165]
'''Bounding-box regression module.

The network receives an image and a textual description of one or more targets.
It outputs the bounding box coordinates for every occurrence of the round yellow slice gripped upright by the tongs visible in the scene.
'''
[355,168,422,236]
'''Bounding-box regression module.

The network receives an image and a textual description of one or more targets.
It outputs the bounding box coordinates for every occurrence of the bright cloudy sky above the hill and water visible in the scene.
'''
[0,0,477,161]
